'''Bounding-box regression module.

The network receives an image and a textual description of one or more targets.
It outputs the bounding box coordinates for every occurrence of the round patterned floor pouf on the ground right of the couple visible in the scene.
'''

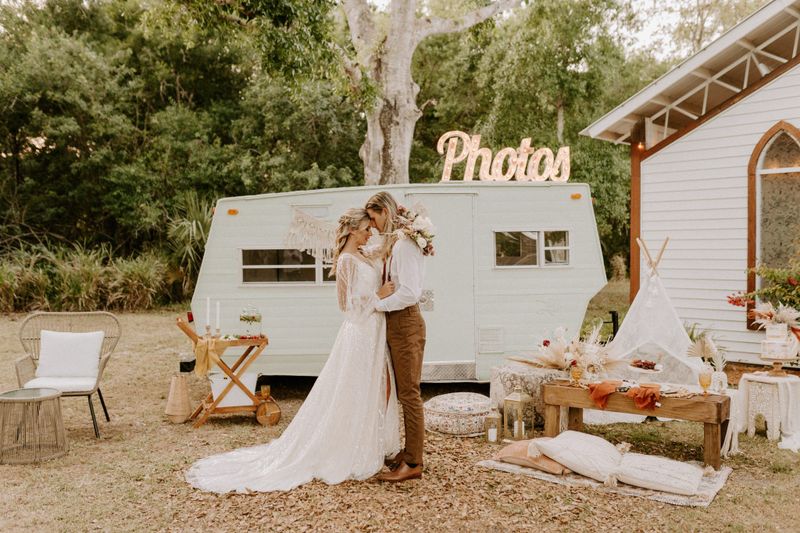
[425,392,491,437]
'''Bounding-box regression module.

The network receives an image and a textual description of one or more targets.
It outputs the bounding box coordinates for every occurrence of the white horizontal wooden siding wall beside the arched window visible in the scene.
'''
[641,60,800,362]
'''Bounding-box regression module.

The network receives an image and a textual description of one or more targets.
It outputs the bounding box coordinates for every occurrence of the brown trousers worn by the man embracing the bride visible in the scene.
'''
[386,305,425,465]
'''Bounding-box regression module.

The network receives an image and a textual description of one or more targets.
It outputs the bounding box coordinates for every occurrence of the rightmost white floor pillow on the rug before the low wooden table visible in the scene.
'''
[617,453,703,496]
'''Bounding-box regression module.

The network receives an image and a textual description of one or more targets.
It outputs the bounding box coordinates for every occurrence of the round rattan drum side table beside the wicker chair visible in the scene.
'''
[0,389,69,464]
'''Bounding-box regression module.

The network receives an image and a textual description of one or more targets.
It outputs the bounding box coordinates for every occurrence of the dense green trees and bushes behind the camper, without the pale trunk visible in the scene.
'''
[0,0,692,296]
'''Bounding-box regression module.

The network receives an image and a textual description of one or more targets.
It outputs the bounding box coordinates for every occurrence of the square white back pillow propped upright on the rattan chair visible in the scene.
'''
[36,330,105,378]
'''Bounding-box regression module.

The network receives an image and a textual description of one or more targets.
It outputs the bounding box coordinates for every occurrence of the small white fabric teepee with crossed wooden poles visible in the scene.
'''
[608,238,703,385]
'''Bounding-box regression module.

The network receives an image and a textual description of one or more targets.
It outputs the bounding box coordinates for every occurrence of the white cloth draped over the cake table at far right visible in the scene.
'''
[731,372,800,452]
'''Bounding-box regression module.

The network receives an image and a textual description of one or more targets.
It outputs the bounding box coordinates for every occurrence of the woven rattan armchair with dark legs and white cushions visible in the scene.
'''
[16,311,120,438]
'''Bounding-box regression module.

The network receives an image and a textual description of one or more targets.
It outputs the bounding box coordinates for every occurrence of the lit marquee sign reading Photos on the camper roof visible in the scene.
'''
[436,131,570,181]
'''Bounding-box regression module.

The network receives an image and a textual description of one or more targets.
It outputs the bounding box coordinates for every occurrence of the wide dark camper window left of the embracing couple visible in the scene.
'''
[242,249,323,283]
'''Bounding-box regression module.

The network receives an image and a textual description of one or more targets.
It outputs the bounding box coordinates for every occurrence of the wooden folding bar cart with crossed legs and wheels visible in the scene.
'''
[177,318,280,428]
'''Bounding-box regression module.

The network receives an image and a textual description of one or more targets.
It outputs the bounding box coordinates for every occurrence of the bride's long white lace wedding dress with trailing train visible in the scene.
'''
[186,253,400,493]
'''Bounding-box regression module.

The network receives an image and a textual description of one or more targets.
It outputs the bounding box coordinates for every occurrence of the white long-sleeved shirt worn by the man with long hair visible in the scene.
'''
[375,238,425,311]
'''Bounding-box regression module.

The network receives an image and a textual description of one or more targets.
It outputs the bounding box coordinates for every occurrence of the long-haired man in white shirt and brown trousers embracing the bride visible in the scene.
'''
[366,192,425,481]
